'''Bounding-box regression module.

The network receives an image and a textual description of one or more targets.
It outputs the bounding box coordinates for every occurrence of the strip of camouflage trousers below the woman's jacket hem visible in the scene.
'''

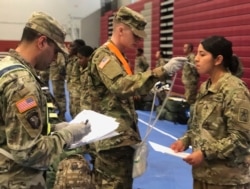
[194,180,250,189]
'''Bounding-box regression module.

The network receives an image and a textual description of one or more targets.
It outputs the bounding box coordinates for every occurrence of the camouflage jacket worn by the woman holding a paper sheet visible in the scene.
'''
[181,73,250,185]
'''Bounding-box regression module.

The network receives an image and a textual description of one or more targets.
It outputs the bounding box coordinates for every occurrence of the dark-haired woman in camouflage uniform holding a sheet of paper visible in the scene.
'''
[171,36,250,189]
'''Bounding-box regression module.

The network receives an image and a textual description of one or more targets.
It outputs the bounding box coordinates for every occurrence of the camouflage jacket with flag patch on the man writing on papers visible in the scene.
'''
[0,50,70,188]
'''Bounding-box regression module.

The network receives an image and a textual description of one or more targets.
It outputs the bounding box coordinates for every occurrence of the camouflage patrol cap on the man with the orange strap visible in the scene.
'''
[114,6,147,38]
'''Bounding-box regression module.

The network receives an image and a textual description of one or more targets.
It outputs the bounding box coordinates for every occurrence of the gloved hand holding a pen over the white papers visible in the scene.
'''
[62,122,91,146]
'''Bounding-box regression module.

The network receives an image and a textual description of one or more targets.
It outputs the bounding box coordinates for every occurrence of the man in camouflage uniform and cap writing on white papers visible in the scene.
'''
[0,12,90,189]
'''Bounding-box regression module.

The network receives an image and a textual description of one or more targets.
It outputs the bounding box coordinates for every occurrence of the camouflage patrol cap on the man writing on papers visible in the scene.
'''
[25,12,68,54]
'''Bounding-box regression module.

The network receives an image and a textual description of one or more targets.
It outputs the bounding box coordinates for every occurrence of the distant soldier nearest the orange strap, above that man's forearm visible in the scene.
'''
[135,48,149,73]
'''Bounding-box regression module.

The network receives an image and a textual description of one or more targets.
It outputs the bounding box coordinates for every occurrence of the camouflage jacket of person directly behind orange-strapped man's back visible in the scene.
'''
[80,68,91,110]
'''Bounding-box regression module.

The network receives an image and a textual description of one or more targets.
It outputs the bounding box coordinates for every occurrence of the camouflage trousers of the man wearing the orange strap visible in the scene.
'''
[94,146,134,189]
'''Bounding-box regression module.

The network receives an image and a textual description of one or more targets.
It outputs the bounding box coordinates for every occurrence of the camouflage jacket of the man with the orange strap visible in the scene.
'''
[88,42,158,150]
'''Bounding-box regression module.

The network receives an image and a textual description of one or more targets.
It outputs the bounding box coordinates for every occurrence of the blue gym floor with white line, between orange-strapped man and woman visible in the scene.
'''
[133,111,192,189]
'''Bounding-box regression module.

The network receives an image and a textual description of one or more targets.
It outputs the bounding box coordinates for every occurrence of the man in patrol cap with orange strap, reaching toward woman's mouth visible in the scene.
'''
[88,7,186,189]
